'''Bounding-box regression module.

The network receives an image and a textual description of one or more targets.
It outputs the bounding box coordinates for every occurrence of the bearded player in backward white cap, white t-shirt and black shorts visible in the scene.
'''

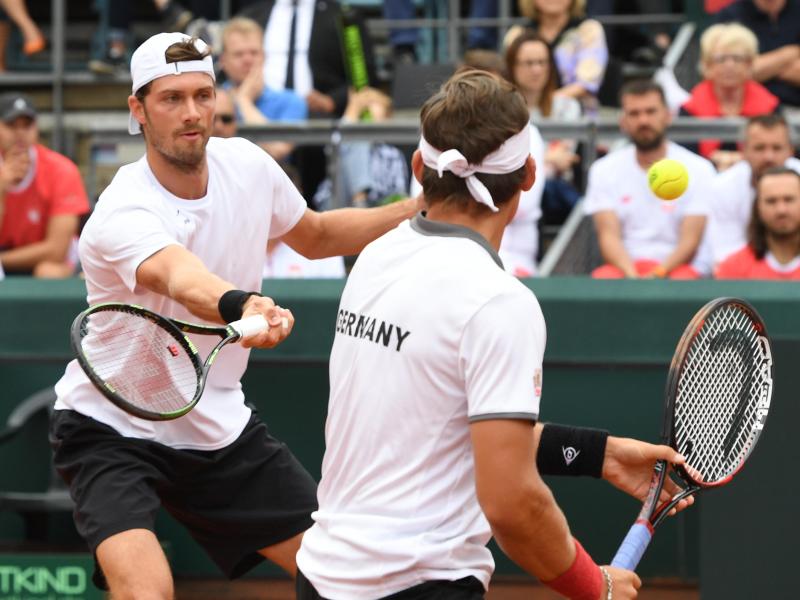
[50,33,416,600]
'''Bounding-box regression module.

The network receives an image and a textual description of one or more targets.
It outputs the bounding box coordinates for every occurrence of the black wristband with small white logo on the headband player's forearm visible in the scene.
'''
[536,423,608,478]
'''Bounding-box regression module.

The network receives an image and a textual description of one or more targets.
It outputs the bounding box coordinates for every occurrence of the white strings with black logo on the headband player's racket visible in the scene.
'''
[675,305,770,483]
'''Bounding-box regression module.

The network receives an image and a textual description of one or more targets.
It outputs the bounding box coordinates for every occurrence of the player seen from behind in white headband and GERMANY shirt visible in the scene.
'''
[297,70,688,600]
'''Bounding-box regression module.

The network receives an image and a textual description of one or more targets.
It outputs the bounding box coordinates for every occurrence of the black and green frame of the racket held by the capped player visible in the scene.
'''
[70,302,241,421]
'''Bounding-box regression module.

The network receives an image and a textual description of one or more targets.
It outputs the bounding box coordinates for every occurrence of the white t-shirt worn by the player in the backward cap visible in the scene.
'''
[56,138,306,450]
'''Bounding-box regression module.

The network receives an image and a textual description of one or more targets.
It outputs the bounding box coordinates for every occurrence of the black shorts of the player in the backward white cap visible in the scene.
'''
[50,410,317,585]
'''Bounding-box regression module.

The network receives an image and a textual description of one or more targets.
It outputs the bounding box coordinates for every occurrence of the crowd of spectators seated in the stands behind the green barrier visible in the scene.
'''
[0,0,800,279]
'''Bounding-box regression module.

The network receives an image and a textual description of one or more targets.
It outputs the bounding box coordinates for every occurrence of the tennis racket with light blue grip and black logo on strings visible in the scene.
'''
[611,298,772,570]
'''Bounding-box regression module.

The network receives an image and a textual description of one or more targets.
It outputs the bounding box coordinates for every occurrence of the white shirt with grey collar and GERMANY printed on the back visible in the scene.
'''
[297,216,546,600]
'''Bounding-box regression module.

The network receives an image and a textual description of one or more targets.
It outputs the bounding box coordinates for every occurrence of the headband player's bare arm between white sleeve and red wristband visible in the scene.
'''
[470,419,575,581]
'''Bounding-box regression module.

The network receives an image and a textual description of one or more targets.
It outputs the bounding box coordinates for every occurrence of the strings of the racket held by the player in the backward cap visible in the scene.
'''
[81,311,198,413]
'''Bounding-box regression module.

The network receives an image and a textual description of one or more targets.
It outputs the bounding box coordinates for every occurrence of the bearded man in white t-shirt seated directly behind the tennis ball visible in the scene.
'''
[585,80,715,279]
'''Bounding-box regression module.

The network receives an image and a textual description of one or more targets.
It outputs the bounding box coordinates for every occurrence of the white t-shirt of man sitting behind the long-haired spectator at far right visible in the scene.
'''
[708,157,800,264]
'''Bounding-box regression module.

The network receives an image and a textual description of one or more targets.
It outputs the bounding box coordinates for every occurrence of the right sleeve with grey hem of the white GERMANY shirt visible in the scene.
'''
[459,291,546,422]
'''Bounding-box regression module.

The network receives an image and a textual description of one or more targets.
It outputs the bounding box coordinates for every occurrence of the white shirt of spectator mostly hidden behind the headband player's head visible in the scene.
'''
[410,123,547,277]
